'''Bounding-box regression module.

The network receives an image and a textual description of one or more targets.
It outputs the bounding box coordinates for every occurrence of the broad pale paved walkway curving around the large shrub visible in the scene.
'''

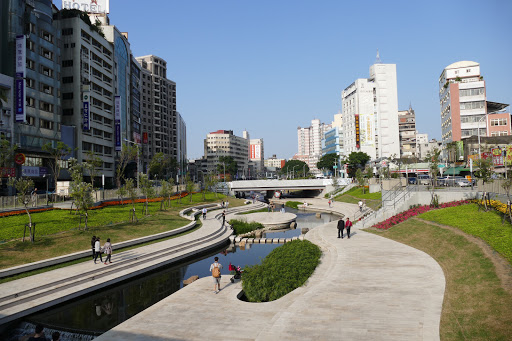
[97,199,445,341]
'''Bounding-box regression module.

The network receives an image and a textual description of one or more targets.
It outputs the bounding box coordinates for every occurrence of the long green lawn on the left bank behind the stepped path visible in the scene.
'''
[0,193,243,269]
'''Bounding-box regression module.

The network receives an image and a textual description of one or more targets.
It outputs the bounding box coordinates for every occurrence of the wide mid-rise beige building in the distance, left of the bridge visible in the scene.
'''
[204,130,249,178]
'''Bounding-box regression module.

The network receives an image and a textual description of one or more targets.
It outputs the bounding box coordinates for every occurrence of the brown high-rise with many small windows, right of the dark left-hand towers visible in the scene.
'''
[137,55,180,173]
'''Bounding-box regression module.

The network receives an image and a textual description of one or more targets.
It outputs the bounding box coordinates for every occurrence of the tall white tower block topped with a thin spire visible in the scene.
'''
[341,60,400,159]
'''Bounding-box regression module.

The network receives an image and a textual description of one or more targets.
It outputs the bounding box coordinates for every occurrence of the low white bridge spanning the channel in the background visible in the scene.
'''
[228,179,350,192]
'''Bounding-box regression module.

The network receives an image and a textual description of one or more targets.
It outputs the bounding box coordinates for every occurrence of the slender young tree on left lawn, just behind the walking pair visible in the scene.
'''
[69,162,94,231]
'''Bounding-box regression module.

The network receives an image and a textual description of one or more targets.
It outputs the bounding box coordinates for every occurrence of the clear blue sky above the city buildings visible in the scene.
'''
[58,0,512,158]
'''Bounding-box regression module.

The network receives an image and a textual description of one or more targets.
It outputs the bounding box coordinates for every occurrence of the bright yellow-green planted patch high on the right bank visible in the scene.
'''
[418,204,512,264]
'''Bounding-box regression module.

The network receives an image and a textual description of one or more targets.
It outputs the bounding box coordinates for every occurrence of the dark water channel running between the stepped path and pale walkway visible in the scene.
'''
[0,207,338,341]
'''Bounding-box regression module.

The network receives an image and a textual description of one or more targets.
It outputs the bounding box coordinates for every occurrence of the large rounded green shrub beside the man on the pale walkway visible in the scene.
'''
[242,240,322,302]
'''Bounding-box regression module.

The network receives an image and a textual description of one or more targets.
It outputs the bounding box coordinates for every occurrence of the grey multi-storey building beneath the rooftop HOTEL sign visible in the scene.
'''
[55,10,115,187]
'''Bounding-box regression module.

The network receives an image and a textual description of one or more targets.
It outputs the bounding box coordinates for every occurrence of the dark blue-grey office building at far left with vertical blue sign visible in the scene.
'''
[0,0,61,183]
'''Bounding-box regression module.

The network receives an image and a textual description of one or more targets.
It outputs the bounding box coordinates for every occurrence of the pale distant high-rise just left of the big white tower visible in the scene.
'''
[293,119,331,173]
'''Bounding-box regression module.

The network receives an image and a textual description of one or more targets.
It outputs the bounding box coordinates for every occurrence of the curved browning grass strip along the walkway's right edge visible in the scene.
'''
[366,216,512,340]
